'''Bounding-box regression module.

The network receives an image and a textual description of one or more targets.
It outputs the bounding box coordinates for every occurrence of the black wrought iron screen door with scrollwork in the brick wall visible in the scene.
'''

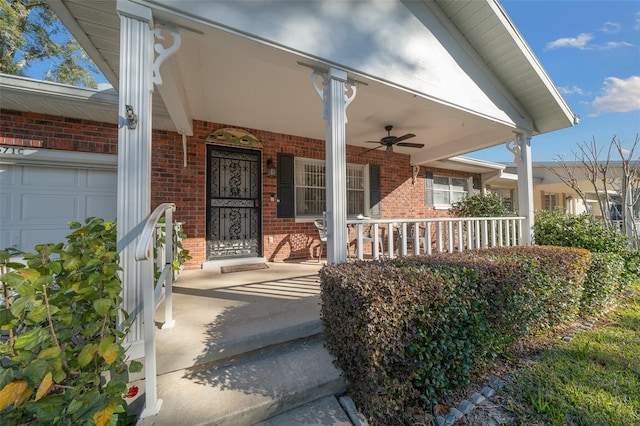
[207,145,262,260]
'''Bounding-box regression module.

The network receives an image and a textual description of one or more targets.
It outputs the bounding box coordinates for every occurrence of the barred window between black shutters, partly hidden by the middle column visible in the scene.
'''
[295,157,368,218]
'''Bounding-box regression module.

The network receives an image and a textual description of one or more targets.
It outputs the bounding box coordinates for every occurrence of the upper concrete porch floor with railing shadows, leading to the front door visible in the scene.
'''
[156,260,324,374]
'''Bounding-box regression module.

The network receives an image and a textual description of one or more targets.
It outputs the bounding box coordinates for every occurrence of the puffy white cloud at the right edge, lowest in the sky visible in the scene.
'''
[591,76,640,115]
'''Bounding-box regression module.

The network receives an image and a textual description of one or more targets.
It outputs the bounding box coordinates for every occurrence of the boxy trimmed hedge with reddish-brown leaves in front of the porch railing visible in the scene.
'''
[320,246,590,424]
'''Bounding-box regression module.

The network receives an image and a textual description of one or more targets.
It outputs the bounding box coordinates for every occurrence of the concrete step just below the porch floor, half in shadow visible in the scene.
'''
[131,335,348,426]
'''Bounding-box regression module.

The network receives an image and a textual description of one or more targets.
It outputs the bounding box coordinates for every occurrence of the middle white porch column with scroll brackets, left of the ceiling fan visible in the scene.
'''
[312,68,356,263]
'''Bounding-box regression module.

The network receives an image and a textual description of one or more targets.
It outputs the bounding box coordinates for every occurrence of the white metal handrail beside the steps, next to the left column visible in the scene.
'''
[135,203,176,417]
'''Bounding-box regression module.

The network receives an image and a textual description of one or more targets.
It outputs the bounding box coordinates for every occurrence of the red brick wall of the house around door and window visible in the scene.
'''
[0,110,478,268]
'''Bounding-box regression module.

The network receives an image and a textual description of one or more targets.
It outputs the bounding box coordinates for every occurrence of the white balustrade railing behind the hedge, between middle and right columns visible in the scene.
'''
[347,216,525,259]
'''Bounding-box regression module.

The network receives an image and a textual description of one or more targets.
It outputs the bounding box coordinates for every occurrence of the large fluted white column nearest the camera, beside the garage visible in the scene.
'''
[117,0,154,358]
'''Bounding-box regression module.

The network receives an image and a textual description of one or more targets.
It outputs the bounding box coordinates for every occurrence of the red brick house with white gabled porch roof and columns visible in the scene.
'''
[2,0,577,392]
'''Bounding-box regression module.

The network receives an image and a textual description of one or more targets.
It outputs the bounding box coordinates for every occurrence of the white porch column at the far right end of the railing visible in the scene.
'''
[512,132,534,245]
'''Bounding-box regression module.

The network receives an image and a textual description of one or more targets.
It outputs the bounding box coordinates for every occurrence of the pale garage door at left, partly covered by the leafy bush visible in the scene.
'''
[0,148,117,252]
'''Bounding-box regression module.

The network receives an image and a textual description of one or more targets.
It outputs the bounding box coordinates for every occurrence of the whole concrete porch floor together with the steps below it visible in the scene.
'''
[131,262,351,425]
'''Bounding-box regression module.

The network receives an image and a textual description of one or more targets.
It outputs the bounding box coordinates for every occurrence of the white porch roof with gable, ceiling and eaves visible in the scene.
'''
[41,0,573,164]
